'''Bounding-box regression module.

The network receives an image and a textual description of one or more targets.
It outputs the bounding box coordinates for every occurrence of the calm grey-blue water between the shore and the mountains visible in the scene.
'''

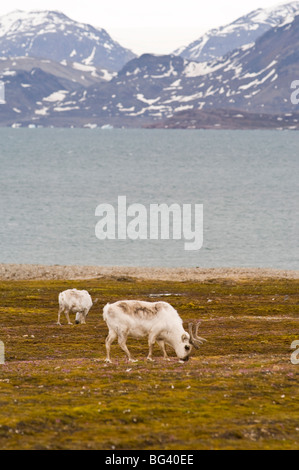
[0,129,299,269]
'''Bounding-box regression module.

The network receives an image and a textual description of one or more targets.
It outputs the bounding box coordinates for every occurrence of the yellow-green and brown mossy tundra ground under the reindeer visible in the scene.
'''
[0,278,299,450]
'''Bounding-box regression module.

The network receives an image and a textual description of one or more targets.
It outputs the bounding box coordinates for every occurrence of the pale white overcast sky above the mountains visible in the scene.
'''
[0,0,289,54]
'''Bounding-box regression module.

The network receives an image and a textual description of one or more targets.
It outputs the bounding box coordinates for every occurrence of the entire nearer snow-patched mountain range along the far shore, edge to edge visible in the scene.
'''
[0,4,299,129]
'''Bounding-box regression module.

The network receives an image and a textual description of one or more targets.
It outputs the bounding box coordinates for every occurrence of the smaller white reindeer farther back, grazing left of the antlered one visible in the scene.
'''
[57,289,93,325]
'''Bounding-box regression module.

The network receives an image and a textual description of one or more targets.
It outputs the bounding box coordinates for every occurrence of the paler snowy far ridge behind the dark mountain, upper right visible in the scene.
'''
[174,1,299,62]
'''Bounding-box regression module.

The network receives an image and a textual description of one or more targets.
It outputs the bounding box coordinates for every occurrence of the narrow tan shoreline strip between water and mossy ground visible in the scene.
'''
[0,264,299,282]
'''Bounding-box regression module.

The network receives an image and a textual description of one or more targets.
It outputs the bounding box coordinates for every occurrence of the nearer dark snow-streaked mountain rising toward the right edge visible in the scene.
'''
[26,12,299,127]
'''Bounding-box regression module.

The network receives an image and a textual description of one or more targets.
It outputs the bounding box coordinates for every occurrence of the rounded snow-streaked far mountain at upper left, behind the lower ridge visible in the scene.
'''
[0,10,135,71]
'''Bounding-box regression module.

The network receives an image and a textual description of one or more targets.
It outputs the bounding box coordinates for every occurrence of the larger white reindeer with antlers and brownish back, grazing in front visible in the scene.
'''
[103,300,206,362]
